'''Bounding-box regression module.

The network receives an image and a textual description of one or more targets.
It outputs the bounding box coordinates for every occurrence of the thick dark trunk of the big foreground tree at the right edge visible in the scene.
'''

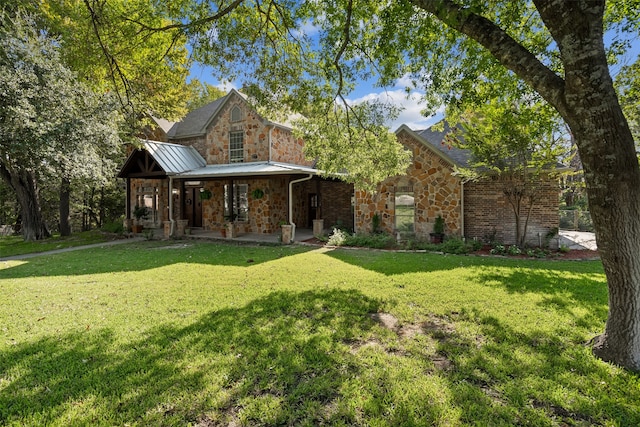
[541,2,640,371]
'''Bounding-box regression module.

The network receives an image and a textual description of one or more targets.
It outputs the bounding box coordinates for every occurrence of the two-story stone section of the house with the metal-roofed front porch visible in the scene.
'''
[118,90,353,241]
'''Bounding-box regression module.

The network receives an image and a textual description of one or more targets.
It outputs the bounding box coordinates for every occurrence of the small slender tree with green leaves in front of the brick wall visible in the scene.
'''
[447,100,562,247]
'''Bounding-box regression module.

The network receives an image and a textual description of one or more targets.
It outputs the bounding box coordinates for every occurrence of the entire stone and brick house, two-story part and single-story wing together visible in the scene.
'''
[118,90,559,245]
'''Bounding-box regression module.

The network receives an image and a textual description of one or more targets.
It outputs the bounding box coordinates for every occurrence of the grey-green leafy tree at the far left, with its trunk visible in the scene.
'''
[0,15,120,240]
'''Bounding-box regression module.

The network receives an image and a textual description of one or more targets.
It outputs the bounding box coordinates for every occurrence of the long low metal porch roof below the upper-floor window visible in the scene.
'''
[176,162,320,179]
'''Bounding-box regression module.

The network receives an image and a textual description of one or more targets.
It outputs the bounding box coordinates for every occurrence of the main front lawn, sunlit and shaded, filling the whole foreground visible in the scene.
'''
[0,241,640,426]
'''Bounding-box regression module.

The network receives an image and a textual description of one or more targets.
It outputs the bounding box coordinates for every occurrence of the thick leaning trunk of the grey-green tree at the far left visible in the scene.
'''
[0,164,51,241]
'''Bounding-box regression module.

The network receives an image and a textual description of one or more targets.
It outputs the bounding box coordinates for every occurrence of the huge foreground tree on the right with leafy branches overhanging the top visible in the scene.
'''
[90,0,640,370]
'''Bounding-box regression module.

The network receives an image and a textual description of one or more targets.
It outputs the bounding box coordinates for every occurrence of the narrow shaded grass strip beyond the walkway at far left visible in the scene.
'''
[0,230,113,258]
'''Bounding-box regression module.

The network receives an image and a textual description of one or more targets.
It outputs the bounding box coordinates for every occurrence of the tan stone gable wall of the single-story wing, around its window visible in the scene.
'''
[356,132,462,240]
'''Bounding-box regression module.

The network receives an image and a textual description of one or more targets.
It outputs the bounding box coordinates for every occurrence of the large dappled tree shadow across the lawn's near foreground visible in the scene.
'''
[0,290,640,426]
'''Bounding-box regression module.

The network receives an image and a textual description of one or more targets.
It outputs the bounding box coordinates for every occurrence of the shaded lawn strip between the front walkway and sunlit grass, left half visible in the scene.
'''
[0,241,313,278]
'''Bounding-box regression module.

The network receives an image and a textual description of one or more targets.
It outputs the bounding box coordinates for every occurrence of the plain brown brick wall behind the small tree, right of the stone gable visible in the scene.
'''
[464,177,560,246]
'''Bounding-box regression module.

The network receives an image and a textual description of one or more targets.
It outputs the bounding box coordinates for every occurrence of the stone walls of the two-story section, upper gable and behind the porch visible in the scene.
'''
[129,91,353,234]
